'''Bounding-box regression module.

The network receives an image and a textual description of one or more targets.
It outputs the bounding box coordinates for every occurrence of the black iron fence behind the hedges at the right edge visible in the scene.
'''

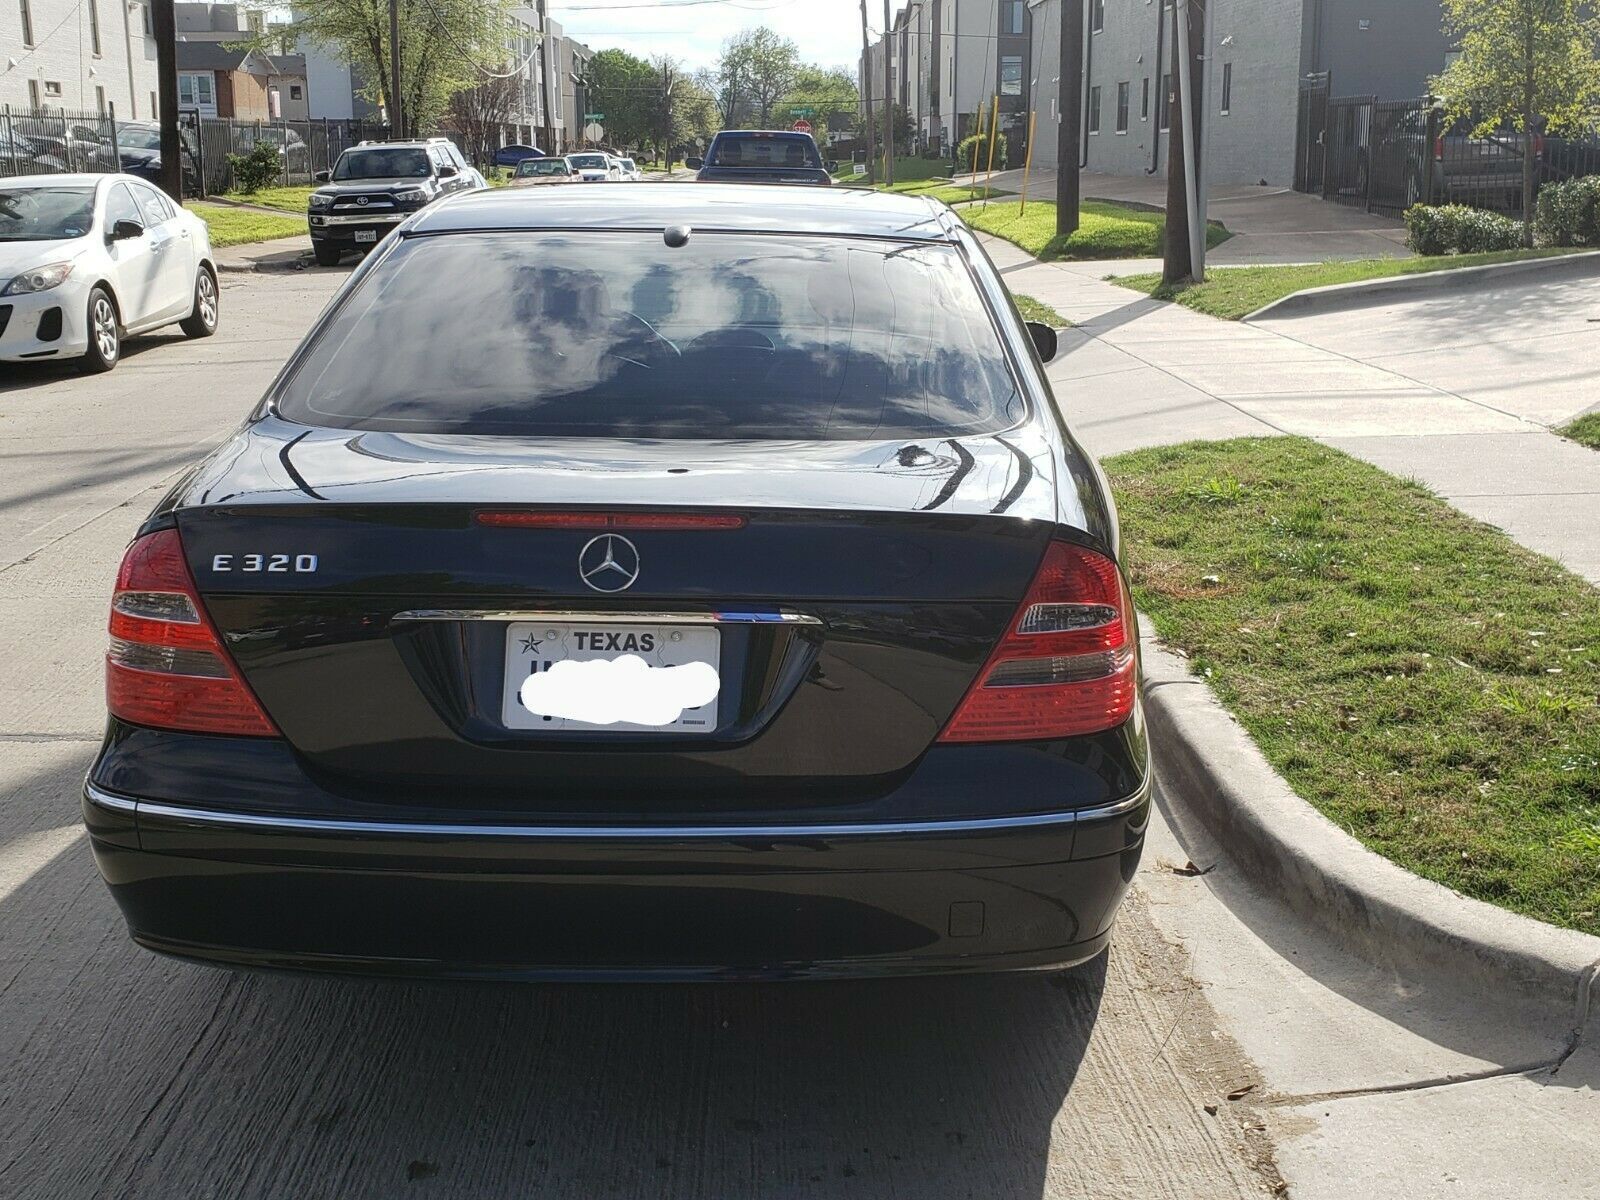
[1294,91,1600,216]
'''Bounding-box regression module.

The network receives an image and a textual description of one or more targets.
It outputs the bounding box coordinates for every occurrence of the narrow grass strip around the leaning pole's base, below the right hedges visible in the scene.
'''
[1112,248,1574,320]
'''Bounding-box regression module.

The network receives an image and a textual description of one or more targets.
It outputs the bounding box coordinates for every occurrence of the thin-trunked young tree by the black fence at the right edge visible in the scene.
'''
[1432,0,1600,246]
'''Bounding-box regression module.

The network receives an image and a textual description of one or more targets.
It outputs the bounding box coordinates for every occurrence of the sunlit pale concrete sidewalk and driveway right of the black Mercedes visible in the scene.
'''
[984,237,1600,584]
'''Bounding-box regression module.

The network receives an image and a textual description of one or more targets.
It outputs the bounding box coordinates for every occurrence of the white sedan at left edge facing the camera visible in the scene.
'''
[0,174,218,371]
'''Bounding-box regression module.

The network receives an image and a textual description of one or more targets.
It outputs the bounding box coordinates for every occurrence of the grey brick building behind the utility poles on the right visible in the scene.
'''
[1030,0,1451,186]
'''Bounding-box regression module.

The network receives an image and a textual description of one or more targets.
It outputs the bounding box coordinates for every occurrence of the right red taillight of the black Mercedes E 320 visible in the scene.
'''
[939,542,1138,742]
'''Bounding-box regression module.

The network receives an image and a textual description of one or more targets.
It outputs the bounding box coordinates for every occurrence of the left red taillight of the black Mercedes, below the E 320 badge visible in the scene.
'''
[106,530,278,738]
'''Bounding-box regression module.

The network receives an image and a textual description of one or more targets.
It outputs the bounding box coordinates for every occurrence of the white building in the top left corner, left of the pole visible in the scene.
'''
[0,0,157,120]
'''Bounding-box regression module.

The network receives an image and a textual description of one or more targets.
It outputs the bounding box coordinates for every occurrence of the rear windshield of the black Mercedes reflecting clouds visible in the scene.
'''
[277,232,1024,440]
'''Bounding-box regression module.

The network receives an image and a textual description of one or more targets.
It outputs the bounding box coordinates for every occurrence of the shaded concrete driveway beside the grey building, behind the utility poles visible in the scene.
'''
[955,170,1411,267]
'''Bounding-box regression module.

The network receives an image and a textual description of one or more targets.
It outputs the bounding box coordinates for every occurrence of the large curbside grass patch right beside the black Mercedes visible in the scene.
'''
[1104,438,1600,933]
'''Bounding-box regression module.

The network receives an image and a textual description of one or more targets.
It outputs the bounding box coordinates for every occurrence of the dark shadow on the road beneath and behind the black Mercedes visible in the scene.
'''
[0,747,1100,1200]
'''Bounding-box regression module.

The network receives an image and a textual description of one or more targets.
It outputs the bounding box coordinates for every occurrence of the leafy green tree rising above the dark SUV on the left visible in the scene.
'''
[284,0,512,136]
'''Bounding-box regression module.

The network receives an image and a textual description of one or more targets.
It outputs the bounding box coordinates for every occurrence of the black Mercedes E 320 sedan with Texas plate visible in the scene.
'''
[83,184,1150,979]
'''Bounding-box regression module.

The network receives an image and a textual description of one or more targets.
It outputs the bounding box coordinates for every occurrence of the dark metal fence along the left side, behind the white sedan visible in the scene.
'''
[0,107,403,195]
